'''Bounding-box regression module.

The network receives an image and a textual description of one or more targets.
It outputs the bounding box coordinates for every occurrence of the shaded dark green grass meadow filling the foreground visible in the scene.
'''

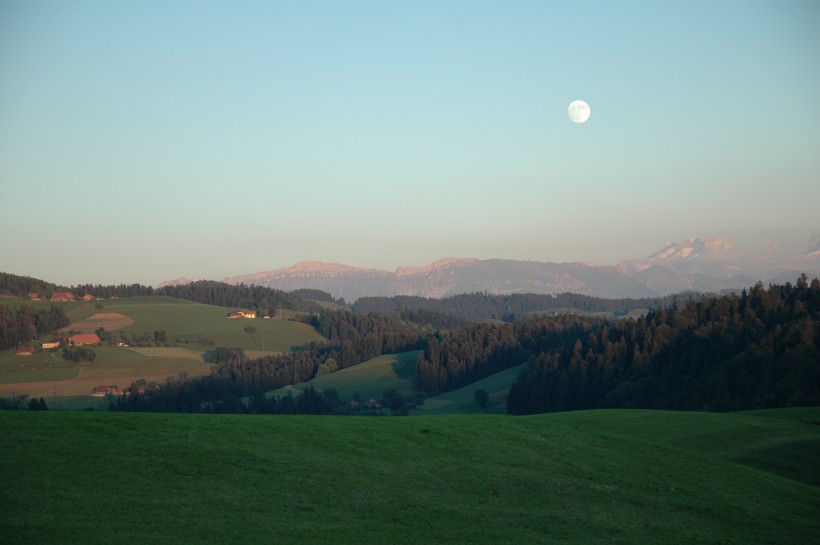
[0,409,820,545]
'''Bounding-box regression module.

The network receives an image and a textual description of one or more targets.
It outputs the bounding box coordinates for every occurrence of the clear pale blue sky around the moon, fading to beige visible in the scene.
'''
[0,0,820,285]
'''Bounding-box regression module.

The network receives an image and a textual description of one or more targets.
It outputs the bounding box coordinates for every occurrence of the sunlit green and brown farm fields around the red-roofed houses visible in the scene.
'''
[0,297,324,400]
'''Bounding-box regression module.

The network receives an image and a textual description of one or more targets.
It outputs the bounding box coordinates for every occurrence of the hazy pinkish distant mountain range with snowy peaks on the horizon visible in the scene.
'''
[162,236,820,302]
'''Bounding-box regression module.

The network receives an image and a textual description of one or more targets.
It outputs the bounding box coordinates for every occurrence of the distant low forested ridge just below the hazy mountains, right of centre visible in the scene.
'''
[353,293,680,322]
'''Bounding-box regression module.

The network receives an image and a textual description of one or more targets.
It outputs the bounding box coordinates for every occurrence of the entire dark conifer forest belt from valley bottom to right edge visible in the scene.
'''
[102,276,820,414]
